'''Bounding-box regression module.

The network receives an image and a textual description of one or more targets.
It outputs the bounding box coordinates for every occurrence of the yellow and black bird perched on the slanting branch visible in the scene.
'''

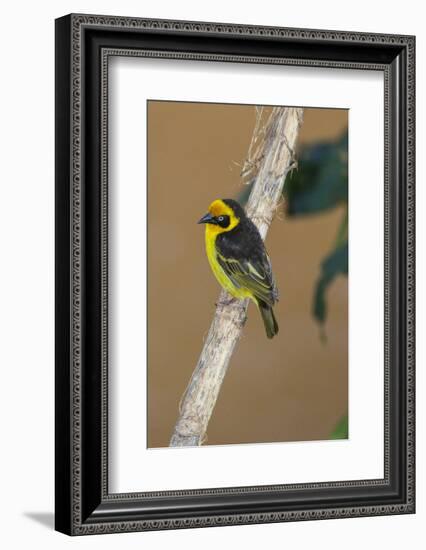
[198,199,278,338]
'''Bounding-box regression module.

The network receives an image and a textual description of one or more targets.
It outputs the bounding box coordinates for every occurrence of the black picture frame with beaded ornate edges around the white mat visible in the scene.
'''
[55,14,415,535]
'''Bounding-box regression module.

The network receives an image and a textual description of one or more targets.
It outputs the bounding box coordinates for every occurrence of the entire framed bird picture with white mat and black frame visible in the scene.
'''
[55,14,415,535]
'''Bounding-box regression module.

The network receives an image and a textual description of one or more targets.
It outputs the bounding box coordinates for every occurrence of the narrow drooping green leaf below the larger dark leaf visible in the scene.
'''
[313,241,348,323]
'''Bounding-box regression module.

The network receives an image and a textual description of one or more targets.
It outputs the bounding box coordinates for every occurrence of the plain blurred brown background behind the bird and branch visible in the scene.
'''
[148,101,348,447]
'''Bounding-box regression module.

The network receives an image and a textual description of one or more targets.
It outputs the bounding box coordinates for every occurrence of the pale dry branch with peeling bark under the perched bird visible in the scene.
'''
[170,107,303,447]
